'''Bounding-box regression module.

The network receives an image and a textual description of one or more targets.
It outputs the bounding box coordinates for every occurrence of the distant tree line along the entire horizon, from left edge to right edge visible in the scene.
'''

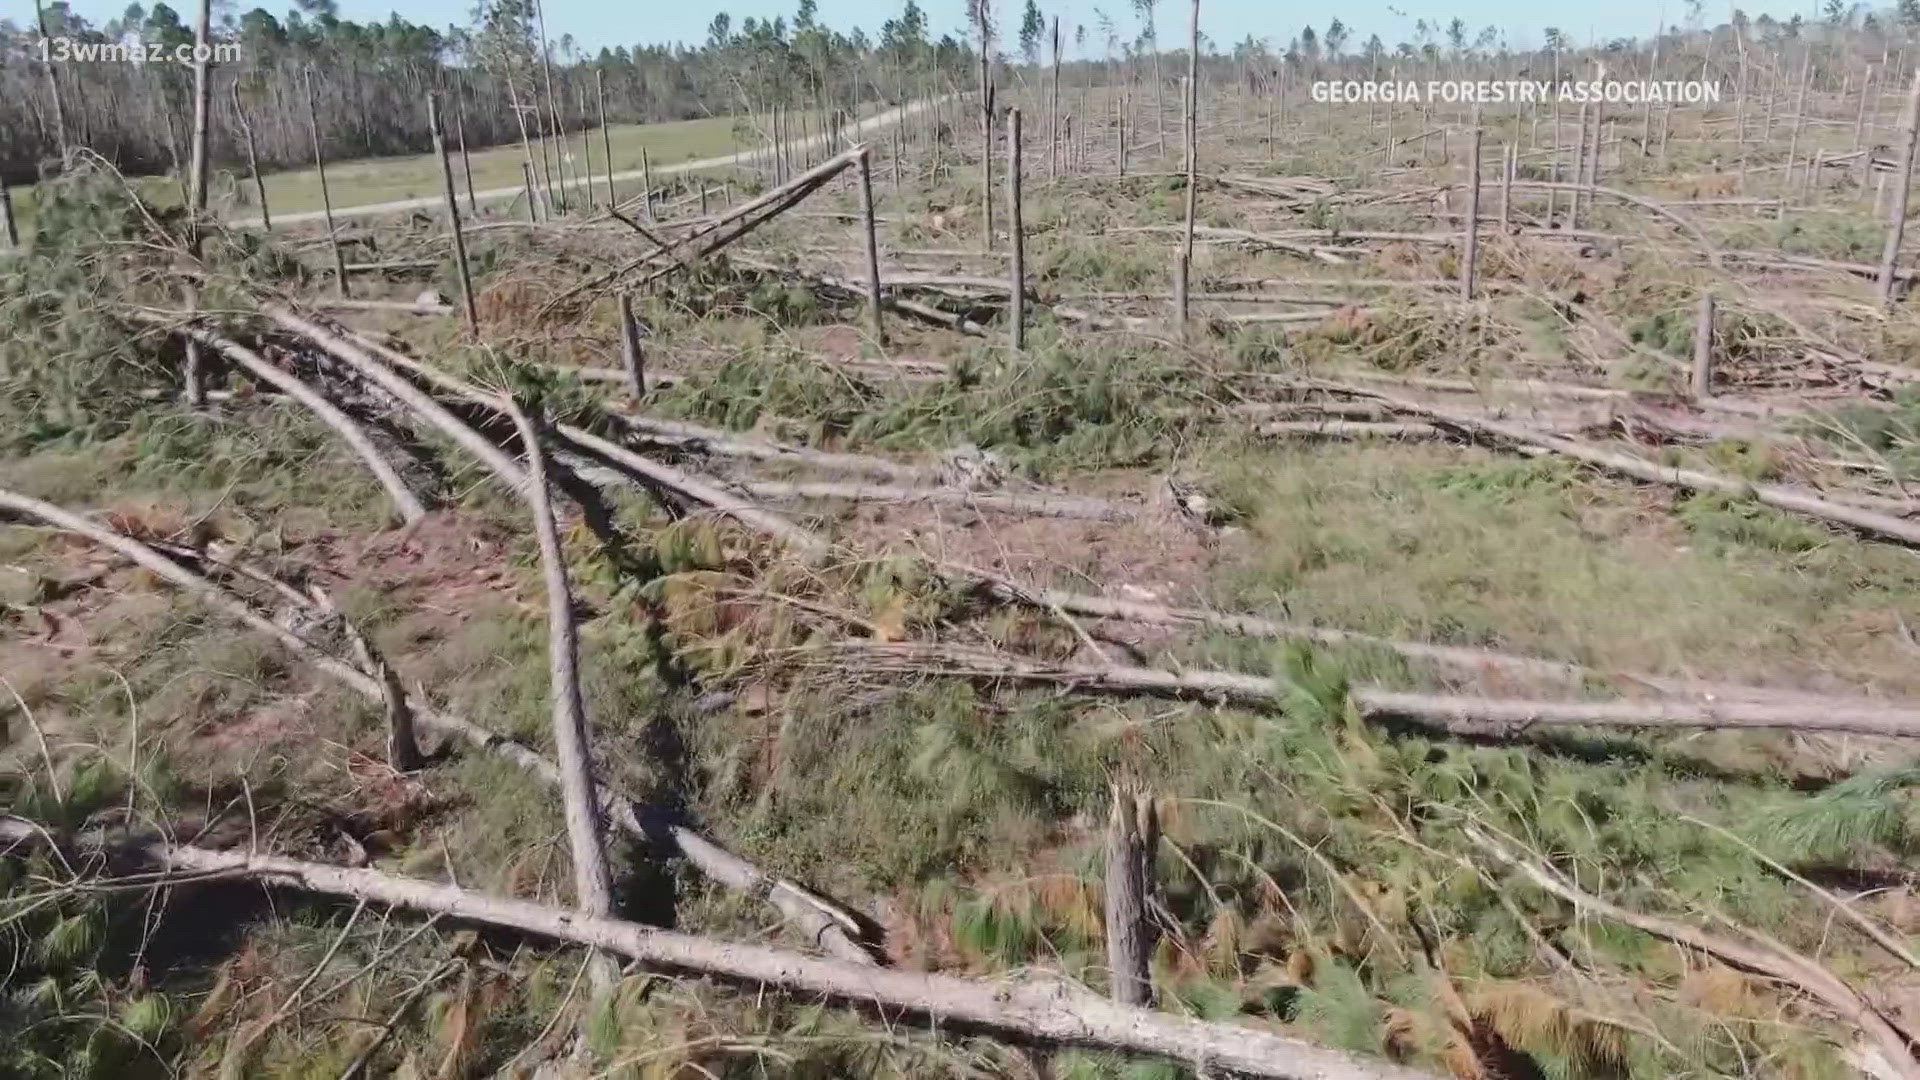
[0,0,1920,183]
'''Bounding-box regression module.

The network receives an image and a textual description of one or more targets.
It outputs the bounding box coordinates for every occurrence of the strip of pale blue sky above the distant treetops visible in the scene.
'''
[0,0,1843,50]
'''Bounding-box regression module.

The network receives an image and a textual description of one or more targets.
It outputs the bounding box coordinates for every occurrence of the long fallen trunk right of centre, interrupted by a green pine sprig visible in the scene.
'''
[831,642,1920,738]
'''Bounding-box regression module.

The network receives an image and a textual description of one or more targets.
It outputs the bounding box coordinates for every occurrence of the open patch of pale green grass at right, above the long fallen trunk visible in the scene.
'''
[1221,446,1920,686]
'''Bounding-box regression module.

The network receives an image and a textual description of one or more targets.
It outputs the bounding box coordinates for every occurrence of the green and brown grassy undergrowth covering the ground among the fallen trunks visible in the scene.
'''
[0,84,1920,1080]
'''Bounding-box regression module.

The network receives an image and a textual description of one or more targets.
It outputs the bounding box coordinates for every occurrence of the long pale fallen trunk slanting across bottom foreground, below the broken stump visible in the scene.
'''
[0,817,1434,1080]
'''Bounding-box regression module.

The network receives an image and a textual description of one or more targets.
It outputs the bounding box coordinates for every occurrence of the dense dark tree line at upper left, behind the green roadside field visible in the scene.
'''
[0,0,975,183]
